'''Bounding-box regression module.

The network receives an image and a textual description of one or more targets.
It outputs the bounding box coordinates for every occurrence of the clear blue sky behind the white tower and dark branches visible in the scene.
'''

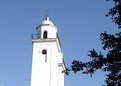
[0,0,117,86]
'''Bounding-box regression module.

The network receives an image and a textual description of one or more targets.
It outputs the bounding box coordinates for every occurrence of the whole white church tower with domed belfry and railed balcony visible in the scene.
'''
[31,17,65,86]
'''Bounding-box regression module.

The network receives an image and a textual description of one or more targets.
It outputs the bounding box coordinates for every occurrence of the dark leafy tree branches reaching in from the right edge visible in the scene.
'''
[66,0,121,86]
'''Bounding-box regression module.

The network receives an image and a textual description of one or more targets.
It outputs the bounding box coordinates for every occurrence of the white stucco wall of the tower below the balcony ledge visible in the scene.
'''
[31,41,64,86]
